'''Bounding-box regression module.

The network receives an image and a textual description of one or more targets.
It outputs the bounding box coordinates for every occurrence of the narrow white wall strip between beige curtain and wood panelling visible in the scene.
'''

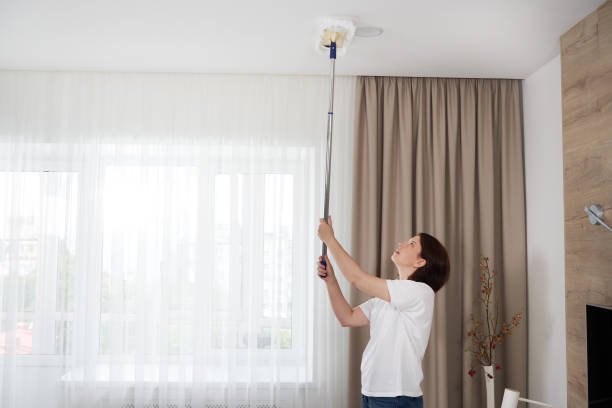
[523,56,567,407]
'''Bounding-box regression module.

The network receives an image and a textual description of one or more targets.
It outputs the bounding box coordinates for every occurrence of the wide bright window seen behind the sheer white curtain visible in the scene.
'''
[0,146,315,381]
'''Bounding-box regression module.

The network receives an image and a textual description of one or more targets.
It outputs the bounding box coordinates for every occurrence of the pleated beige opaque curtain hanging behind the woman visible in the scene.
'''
[350,77,527,408]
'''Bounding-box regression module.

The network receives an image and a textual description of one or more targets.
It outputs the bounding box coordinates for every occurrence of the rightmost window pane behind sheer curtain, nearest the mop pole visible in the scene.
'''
[212,174,294,349]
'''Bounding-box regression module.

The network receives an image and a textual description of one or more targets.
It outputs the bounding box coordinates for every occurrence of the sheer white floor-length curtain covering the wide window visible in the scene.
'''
[0,71,354,408]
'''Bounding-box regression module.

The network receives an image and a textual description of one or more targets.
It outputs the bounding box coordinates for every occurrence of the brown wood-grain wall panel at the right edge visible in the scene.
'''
[561,0,612,408]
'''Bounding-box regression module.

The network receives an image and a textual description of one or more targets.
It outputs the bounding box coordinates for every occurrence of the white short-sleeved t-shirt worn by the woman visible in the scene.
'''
[359,280,434,397]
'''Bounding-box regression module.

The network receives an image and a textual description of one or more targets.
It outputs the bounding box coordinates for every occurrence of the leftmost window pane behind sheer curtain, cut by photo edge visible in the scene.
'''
[0,172,78,354]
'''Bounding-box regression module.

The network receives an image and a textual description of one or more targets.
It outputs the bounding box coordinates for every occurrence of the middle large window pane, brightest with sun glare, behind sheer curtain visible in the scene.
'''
[100,166,198,354]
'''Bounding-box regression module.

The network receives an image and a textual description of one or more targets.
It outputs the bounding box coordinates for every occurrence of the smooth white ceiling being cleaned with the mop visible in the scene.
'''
[0,0,604,78]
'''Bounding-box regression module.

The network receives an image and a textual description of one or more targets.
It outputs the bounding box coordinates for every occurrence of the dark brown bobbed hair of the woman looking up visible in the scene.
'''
[408,232,450,292]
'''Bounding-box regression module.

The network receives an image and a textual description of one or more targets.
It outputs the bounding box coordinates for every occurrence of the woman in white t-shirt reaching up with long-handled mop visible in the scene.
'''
[317,217,450,408]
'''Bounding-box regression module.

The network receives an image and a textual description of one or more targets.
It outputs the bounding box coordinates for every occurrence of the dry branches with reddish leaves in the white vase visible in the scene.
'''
[465,255,521,378]
